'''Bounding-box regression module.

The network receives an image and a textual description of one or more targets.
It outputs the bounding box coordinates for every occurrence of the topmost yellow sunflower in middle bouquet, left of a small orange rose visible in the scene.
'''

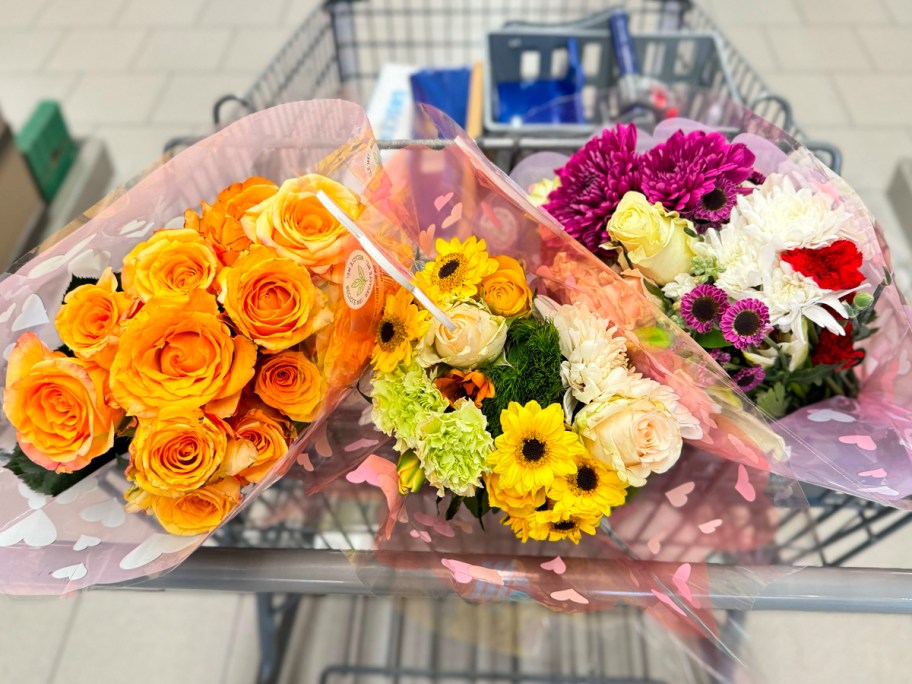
[415,235,498,304]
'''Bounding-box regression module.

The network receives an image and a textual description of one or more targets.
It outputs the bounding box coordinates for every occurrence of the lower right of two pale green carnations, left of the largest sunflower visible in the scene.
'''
[416,399,494,496]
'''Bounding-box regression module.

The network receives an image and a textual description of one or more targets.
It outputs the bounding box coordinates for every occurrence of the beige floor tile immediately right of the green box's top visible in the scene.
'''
[65,74,167,124]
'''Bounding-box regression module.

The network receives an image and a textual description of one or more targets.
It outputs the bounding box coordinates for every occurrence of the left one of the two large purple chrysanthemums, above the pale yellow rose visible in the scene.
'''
[544,125,640,252]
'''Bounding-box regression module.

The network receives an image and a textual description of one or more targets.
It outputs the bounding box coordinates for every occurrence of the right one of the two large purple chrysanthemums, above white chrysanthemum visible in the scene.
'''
[641,131,754,218]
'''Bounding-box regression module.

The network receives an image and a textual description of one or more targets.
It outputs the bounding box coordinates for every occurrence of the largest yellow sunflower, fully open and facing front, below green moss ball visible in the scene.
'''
[488,401,583,495]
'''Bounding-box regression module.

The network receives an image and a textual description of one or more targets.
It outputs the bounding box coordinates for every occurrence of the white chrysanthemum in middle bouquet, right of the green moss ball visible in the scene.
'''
[535,297,627,404]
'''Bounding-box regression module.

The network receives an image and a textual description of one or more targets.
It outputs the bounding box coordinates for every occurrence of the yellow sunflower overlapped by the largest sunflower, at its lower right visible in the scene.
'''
[548,452,627,515]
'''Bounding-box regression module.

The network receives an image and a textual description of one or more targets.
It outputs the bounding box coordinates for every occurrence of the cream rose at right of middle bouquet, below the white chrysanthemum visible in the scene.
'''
[573,397,683,487]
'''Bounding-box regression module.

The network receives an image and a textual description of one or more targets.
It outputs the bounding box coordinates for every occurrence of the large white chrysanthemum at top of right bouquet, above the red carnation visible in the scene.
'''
[729,174,854,272]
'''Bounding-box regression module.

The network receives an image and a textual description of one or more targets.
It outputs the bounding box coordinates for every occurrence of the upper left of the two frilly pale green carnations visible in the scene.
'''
[371,362,449,452]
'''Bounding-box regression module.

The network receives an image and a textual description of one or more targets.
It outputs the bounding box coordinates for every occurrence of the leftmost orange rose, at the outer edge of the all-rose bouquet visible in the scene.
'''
[3,333,123,473]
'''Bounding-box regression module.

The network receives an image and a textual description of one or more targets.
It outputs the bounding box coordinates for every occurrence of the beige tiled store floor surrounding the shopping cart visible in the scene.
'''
[0,0,912,684]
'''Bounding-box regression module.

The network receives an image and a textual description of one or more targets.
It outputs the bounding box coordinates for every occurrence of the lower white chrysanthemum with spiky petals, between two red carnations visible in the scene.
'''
[754,262,850,344]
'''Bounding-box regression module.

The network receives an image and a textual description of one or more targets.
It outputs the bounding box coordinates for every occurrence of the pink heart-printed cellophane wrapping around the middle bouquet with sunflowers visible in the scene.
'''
[328,112,807,664]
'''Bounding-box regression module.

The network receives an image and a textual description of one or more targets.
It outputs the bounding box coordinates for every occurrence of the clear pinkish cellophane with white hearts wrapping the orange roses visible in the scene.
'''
[0,100,388,594]
